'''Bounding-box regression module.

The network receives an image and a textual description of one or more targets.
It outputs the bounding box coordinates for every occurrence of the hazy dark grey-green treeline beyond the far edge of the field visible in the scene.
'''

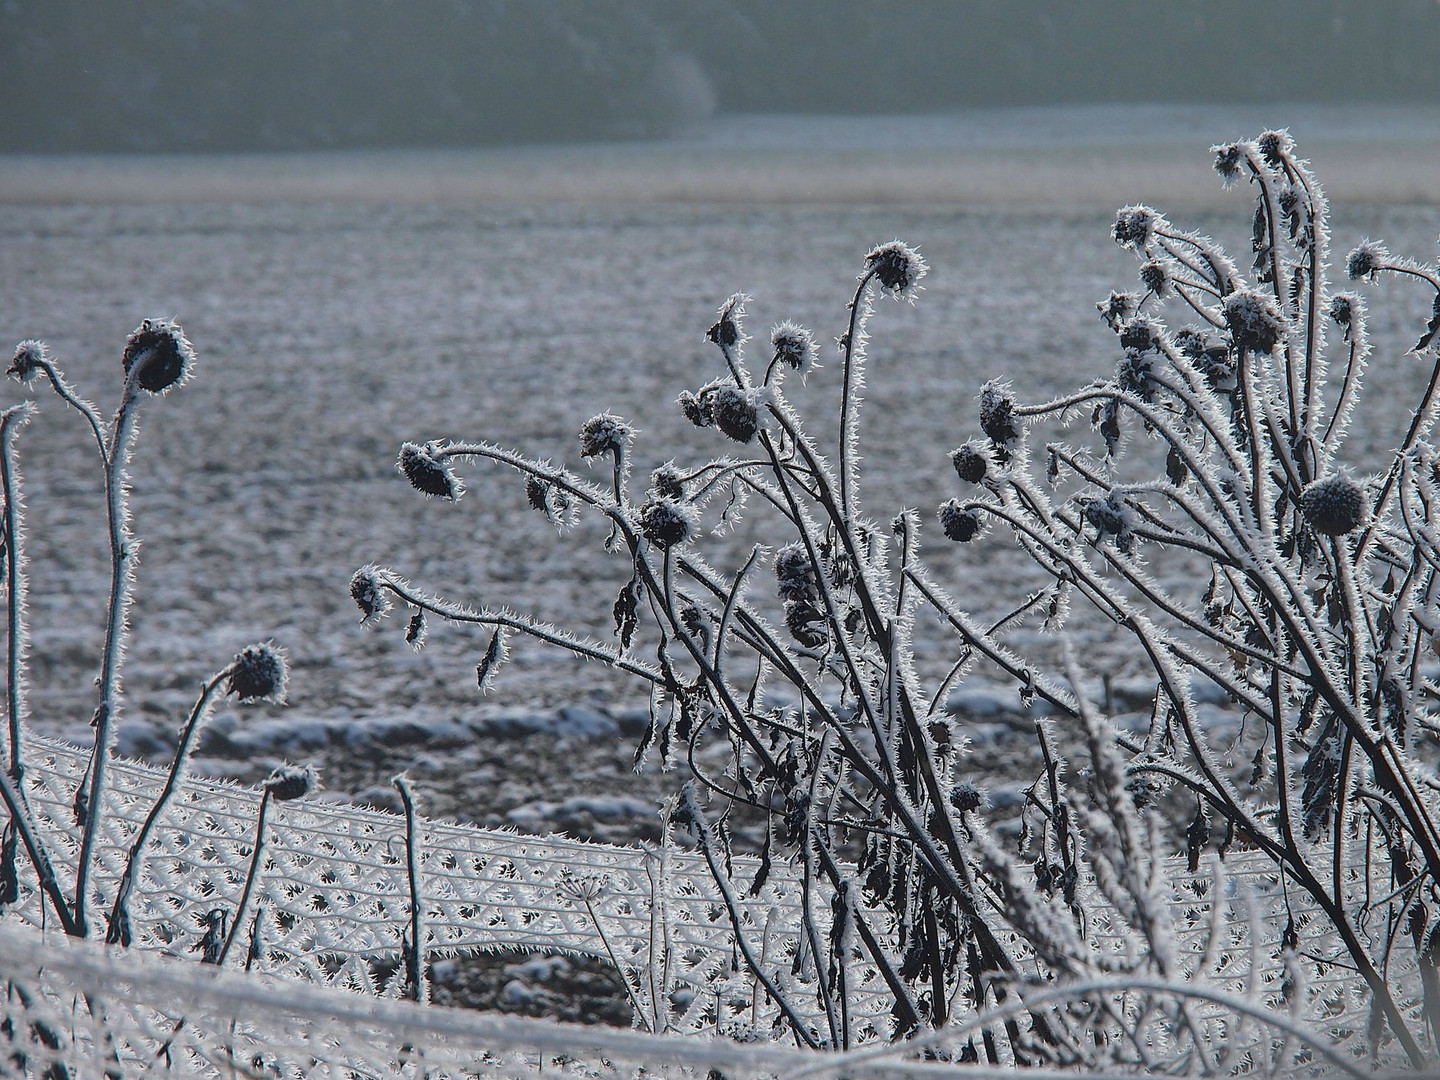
[0,0,1440,153]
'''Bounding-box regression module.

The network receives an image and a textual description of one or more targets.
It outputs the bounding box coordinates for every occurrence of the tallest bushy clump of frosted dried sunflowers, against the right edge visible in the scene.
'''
[917,131,1440,1066]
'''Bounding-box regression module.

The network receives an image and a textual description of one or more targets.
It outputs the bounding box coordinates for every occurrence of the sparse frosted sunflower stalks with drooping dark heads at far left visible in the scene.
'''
[0,329,285,945]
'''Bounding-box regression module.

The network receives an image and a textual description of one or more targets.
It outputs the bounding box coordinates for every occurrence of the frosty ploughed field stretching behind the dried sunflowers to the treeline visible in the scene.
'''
[0,105,1440,837]
